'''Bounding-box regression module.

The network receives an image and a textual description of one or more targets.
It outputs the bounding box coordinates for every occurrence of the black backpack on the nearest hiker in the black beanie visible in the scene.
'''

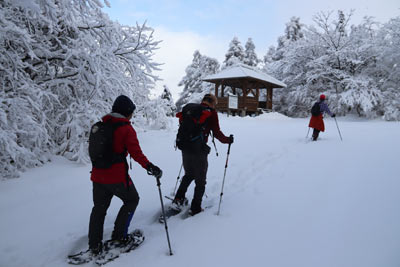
[89,121,129,169]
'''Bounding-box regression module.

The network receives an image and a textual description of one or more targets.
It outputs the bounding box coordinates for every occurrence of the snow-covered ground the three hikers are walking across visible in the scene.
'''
[0,113,400,267]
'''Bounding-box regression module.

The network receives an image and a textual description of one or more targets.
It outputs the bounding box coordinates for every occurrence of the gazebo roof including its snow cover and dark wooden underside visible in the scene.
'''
[203,64,286,88]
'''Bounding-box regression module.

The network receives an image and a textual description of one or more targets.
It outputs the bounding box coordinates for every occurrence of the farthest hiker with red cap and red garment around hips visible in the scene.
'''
[308,94,336,141]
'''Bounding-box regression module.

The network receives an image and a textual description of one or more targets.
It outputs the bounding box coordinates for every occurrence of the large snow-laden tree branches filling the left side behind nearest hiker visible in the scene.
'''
[0,0,164,180]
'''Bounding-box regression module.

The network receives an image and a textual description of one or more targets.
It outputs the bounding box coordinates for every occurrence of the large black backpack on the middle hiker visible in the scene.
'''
[176,103,211,153]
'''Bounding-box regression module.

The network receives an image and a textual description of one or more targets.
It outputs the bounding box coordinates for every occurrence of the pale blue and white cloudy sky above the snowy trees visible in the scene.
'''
[104,0,400,101]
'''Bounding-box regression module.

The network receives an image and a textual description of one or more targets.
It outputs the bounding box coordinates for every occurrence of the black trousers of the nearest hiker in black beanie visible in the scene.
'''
[89,182,139,248]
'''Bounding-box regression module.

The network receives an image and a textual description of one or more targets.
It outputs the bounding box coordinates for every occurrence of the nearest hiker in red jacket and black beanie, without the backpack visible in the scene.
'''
[89,95,162,256]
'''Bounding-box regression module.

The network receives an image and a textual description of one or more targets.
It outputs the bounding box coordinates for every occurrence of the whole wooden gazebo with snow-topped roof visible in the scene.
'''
[203,64,286,115]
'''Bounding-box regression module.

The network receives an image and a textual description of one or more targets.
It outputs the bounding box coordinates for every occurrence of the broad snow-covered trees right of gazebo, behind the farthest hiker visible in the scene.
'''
[264,11,399,119]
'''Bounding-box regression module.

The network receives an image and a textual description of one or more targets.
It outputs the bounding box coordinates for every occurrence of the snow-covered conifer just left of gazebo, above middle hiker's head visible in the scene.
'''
[176,50,220,111]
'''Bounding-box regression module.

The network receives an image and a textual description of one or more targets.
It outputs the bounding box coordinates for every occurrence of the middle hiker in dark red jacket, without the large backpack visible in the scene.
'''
[171,94,233,218]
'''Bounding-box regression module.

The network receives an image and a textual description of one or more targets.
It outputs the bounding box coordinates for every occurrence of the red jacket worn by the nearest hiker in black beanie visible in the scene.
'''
[90,113,149,184]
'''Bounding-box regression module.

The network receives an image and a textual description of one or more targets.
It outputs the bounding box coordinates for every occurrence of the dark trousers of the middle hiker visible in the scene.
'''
[175,151,208,211]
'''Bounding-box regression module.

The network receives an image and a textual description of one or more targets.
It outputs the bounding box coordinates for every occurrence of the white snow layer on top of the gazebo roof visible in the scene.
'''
[202,64,286,88]
